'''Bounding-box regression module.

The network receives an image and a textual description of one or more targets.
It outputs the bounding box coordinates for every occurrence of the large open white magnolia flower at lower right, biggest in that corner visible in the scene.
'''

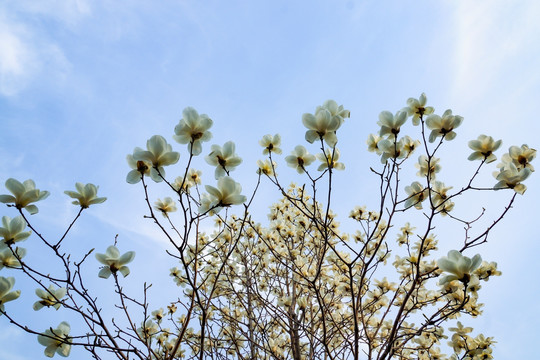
[437,250,482,285]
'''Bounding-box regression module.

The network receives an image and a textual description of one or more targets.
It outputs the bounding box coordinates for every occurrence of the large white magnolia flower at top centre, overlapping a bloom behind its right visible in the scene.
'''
[302,107,341,147]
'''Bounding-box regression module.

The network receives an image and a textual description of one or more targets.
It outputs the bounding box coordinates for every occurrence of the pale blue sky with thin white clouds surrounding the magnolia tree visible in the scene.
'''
[0,0,540,360]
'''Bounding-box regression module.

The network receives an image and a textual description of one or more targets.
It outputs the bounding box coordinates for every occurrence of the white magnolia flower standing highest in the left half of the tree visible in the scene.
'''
[173,107,212,155]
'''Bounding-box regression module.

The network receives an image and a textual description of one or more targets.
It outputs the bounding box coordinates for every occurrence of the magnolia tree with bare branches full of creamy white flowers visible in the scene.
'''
[0,94,536,360]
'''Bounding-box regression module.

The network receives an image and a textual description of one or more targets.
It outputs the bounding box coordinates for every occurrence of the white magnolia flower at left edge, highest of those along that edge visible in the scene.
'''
[0,178,49,215]
